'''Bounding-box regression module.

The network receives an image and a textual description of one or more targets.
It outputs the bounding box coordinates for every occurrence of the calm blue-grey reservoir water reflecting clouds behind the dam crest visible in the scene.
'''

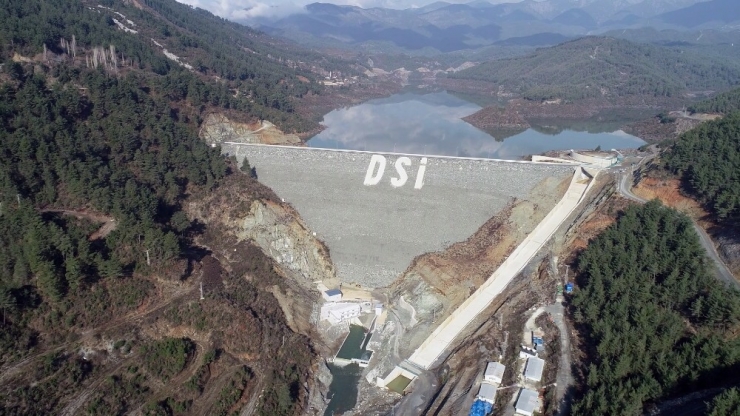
[308,92,645,159]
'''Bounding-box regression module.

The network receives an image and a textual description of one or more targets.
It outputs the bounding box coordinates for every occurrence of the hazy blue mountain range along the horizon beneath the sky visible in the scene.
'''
[250,0,740,52]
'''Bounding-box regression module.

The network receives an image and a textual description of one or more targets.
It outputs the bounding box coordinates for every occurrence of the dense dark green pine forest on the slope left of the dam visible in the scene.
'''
[0,64,228,301]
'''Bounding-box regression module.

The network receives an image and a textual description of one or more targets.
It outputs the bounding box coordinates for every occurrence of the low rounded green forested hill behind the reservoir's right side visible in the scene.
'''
[450,37,740,100]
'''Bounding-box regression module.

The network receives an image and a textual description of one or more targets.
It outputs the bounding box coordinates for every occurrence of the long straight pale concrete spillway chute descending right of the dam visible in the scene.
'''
[378,167,598,387]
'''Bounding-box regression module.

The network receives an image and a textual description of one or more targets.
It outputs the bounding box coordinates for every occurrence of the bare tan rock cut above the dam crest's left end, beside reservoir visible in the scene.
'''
[200,113,303,146]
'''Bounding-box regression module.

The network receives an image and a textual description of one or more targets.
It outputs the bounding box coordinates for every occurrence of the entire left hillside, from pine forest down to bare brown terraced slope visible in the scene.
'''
[0,0,330,416]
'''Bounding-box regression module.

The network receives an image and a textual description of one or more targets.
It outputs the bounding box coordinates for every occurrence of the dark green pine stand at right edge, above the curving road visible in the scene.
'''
[661,112,740,221]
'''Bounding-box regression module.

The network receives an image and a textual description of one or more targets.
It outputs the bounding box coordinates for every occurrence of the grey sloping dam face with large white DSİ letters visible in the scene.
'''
[222,144,574,287]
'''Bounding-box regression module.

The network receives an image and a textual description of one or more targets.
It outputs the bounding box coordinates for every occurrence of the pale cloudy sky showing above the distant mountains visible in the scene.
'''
[178,0,517,20]
